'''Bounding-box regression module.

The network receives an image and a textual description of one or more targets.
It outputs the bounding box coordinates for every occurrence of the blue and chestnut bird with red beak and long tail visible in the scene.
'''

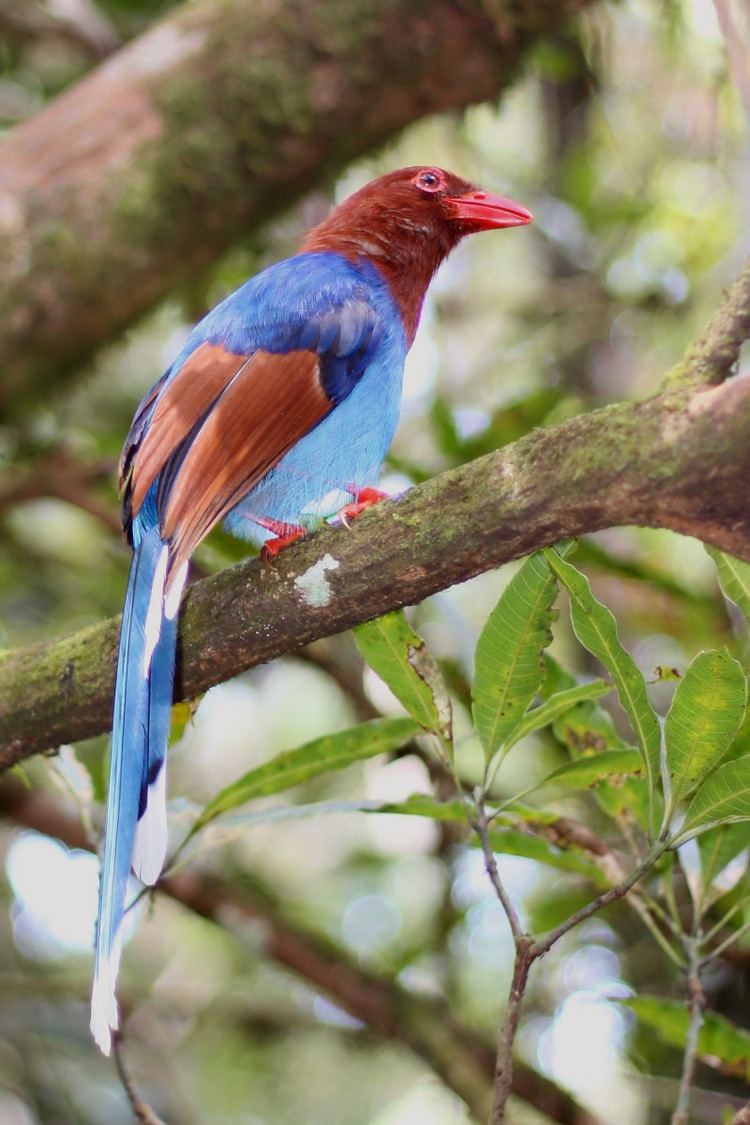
[91,167,533,1054]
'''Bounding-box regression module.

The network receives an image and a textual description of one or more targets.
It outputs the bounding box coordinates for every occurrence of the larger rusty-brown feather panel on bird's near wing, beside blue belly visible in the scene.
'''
[161,350,332,573]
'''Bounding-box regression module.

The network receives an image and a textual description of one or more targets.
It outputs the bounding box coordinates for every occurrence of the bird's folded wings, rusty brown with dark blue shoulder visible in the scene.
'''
[121,285,383,573]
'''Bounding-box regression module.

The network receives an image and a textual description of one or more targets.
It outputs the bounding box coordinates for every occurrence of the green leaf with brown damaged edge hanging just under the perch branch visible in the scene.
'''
[354,610,452,743]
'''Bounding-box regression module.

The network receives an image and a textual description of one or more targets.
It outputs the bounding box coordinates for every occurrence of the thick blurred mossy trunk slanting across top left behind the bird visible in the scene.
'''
[0,0,588,419]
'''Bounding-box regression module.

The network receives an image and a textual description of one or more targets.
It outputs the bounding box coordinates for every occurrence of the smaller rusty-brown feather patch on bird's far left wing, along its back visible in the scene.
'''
[120,343,249,515]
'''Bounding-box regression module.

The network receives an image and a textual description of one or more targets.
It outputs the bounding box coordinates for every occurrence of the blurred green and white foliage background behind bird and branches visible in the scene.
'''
[0,0,750,1125]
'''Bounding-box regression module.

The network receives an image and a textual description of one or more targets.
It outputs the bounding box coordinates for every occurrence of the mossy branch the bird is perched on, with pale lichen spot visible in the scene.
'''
[0,255,750,768]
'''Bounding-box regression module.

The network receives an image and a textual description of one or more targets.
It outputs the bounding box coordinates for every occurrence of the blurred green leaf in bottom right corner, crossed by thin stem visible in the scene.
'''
[620,996,750,1081]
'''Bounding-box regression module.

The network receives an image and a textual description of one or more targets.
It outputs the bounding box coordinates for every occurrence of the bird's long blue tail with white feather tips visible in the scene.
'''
[91,528,184,1054]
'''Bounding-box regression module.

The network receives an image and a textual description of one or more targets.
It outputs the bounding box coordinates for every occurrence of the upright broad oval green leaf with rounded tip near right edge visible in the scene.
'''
[665,649,748,809]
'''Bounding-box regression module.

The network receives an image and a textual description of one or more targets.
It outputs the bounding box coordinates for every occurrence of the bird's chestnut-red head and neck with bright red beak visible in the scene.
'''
[302,165,533,336]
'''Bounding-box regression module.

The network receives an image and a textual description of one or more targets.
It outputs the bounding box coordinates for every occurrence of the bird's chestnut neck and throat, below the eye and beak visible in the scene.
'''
[301,213,459,348]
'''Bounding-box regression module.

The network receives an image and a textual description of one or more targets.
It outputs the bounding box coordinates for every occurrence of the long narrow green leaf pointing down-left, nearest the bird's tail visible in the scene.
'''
[192,718,419,833]
